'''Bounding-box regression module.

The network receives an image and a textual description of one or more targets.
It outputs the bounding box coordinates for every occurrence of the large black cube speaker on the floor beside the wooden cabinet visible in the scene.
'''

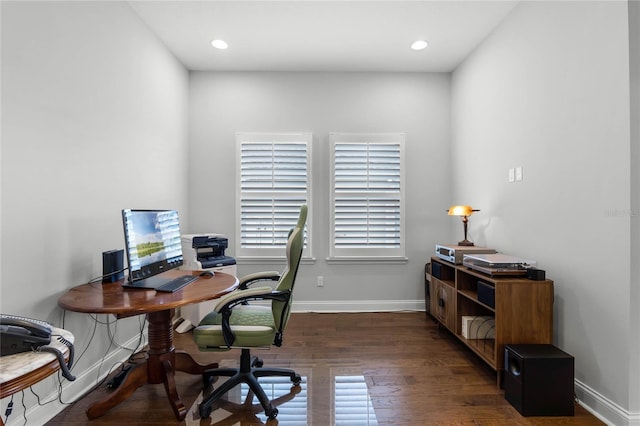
[504,344,574,416]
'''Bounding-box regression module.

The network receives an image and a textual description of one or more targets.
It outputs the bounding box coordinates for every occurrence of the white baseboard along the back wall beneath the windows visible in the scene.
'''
[291,300,425,312]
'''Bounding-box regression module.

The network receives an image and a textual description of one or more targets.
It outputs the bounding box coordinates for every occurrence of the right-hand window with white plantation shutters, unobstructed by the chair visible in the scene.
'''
[330,133,404,260]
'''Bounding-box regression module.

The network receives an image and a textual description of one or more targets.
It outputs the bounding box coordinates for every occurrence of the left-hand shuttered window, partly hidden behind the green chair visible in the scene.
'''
[236,133,311,257]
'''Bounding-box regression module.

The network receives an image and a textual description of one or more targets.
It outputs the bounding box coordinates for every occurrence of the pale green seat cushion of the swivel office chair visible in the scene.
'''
[193,305,276,350]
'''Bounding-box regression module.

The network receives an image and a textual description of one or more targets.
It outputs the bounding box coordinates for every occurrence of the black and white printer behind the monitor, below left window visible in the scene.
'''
[181,234,236,271]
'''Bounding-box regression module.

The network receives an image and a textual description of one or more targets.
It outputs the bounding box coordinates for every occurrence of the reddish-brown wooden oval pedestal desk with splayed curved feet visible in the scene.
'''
[58,270,238,420]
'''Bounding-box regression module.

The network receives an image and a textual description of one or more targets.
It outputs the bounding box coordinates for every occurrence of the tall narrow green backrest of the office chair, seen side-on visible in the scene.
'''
[271,204,307,346]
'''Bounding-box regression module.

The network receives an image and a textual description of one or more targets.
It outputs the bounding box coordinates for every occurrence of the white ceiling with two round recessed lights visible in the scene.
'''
[128,0,518,72]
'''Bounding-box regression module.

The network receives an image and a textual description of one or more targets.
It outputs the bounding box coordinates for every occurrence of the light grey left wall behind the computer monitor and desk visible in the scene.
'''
[0,2,188,424]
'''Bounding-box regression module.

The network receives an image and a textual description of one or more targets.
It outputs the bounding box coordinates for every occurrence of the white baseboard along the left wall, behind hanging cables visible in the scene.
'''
[5,333,147,426]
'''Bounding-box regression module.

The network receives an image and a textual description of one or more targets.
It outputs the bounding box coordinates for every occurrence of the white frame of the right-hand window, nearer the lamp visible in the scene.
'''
[327,132,407,263]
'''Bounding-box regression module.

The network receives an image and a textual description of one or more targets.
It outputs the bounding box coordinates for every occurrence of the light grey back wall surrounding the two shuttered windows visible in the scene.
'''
[189,72,451,310]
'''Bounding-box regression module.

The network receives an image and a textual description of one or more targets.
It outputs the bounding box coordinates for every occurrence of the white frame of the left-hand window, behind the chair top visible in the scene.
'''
[235,132,313,263]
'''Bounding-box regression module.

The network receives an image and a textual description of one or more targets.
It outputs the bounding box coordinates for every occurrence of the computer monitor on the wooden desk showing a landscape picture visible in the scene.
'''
[122,209,183,287]
